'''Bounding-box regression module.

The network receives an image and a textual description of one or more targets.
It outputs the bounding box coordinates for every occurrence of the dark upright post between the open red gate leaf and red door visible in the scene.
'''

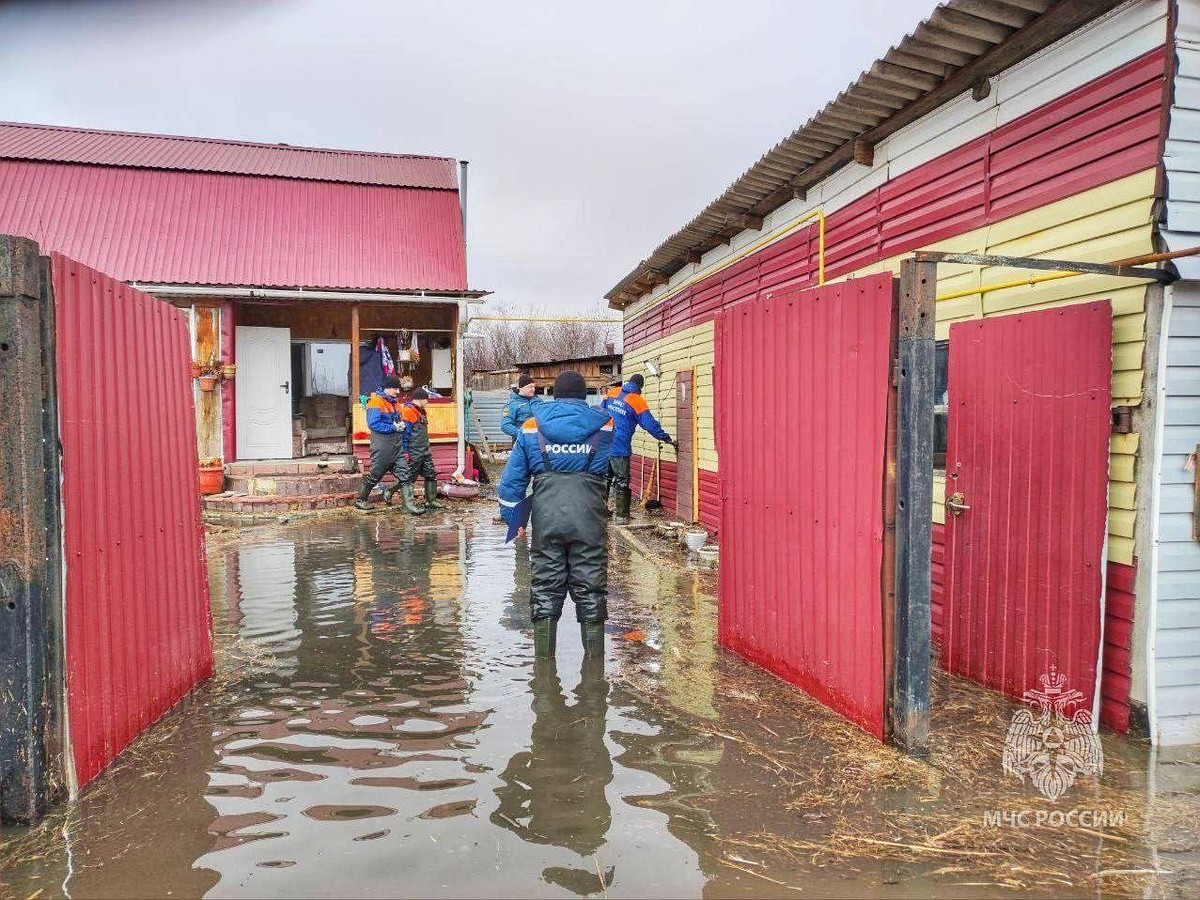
[892,259,937,756]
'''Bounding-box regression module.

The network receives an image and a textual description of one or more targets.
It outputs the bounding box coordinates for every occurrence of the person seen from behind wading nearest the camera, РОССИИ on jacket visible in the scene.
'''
[498,371,613,656]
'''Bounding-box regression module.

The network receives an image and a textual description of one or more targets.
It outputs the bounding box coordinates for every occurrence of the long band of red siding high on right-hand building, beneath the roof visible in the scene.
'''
[624,48,1165,355]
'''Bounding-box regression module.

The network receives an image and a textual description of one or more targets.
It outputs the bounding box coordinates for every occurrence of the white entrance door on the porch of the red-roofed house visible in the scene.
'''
[234,326,292,460]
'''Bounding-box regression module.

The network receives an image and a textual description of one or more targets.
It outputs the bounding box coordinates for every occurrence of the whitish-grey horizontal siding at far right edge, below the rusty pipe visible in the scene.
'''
[1154,283,1200,744]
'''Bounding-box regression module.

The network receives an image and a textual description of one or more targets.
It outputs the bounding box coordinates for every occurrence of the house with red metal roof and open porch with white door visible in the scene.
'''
[0,118,484,496]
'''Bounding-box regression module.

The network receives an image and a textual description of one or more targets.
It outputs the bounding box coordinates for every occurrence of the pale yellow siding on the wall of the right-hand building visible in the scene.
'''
[624,169,1154,564]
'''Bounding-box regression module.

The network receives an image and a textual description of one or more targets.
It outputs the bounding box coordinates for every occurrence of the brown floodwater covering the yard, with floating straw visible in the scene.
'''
[0,506,1200,898]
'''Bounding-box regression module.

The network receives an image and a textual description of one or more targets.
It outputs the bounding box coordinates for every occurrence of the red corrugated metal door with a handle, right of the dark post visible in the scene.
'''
[942,300,1112,710]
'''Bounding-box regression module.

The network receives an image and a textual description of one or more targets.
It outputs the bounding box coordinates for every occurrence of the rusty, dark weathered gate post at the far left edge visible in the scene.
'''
[0,235,62,823]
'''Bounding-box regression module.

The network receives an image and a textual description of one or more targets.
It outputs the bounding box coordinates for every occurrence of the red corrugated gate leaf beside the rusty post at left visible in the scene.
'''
[52,253,212,785]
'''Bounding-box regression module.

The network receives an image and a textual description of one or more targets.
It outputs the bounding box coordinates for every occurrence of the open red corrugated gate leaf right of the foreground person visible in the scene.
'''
[715,275,895,739]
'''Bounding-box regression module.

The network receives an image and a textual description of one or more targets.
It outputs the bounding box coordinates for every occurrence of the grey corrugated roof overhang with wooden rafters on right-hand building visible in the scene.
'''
[605,0,1124,310]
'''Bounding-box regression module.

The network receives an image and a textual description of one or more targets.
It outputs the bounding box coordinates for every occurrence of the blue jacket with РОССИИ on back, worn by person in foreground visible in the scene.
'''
[497,400,613,524]
